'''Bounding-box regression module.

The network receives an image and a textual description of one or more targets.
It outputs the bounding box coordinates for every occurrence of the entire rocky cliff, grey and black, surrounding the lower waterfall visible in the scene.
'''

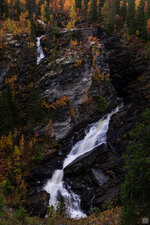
[0,25,150,216]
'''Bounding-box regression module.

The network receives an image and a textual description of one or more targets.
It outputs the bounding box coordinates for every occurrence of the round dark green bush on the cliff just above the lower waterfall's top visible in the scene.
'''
[93,96,108,112]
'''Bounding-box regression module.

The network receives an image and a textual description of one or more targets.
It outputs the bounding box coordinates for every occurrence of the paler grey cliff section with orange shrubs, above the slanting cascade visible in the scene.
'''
[39,29,118,141]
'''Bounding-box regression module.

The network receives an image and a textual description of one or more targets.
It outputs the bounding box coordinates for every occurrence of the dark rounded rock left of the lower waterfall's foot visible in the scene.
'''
[26,191,50,217]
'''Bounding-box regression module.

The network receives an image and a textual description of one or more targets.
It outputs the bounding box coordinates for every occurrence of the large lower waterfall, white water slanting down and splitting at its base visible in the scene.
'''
[44,107,120,218]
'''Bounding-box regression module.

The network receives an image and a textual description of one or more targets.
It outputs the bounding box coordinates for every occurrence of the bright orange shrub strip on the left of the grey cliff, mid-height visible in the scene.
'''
[43,96,68,110]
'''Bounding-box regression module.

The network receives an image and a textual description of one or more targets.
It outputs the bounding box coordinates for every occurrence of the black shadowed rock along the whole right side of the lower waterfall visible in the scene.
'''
[62,29,150,214]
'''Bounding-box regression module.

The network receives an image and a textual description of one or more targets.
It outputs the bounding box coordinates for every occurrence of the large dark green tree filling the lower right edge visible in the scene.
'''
[121,110,150,225]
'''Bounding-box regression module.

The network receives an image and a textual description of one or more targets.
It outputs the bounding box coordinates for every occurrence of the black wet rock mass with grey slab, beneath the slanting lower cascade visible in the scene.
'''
[64,145,124,213]
